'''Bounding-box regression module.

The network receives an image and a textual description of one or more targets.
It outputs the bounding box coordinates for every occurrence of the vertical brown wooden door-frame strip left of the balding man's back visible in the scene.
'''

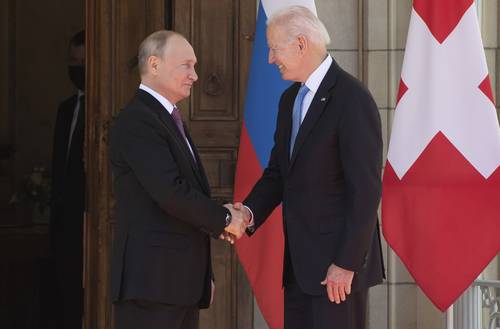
[84,0,114,329]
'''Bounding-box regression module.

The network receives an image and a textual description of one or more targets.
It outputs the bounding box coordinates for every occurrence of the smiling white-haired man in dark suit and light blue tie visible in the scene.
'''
[235,6,384,329]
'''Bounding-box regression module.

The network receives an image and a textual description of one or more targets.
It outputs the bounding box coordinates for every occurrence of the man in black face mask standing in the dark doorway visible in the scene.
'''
[50,31,85,329]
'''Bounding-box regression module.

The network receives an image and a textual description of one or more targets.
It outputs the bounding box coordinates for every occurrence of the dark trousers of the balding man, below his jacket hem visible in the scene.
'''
[114,300,200,329]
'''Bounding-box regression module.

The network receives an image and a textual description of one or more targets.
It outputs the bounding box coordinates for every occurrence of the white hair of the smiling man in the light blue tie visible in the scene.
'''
[267,6,330,48]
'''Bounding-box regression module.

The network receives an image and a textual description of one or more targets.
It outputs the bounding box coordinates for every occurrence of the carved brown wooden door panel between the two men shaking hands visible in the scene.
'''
[172,0,256,329]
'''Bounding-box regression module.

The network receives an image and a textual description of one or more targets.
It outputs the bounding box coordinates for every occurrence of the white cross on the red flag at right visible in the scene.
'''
[387,6,500,179]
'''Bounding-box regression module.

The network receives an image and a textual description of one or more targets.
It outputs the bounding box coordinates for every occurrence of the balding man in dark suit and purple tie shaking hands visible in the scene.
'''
[110,31,247,329]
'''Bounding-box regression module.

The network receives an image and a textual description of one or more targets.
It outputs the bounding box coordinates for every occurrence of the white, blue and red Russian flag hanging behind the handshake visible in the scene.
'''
[234,0,316,329]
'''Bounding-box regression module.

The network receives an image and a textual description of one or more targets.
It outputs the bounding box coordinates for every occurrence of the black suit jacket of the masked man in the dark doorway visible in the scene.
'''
[50,95,85,252]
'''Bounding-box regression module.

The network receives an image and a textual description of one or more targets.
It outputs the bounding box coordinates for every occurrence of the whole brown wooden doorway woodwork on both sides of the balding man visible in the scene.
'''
[84,0,256,329]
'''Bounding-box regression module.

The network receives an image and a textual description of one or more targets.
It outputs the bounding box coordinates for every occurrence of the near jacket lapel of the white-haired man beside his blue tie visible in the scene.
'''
[288,61,339,170]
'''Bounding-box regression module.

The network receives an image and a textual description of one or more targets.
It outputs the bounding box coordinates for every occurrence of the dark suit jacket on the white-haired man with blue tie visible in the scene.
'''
[244,61,384,295]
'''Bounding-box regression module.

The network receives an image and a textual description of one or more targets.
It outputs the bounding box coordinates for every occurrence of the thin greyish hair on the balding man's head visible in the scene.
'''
[137,30,184,75]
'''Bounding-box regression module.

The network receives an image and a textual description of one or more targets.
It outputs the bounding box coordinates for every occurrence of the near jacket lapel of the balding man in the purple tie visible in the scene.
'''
[137,89,208,192]
